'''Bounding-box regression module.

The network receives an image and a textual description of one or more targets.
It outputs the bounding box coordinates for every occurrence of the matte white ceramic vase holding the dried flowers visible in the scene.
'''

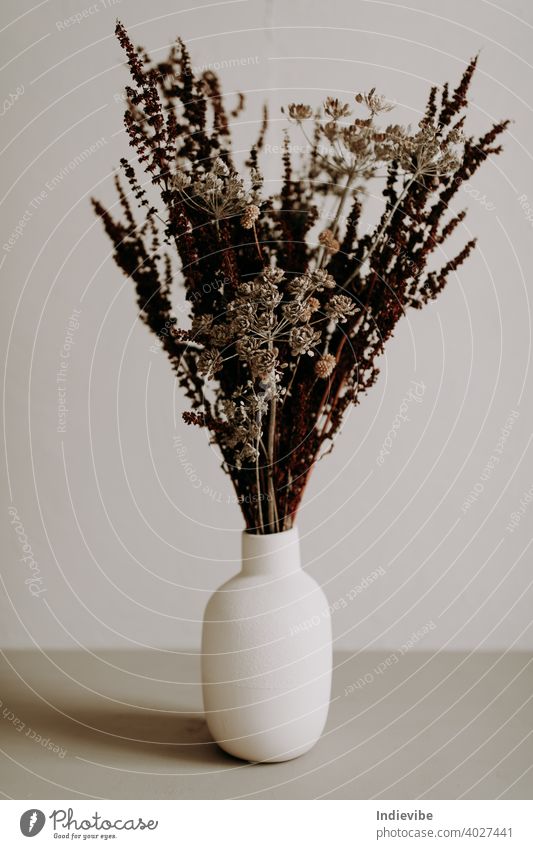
[202,529,332,762]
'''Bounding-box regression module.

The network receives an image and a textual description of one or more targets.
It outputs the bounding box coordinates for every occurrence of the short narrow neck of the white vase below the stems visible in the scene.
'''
[242,528,301,575]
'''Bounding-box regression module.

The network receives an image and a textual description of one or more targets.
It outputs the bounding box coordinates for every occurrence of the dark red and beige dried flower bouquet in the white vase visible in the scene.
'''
[93,23,508,533]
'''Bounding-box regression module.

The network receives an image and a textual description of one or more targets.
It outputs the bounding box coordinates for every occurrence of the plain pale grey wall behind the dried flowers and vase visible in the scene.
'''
[0,0,533,651]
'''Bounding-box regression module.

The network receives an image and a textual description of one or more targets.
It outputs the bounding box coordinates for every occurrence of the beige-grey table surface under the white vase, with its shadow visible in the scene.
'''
[0,651,533,799]
